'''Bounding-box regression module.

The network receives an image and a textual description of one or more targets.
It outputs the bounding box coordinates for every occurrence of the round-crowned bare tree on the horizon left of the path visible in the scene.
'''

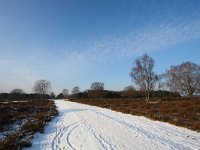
[33,80,51,96]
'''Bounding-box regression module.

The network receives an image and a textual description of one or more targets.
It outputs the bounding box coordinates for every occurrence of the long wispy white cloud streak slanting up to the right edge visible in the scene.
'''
[60,19,200,67]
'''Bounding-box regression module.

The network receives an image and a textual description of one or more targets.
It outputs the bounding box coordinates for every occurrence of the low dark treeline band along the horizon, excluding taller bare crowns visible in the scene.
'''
[0,90,180,101]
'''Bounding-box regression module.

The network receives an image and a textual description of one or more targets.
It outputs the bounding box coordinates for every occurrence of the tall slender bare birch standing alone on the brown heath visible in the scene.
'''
[130,54,158,102]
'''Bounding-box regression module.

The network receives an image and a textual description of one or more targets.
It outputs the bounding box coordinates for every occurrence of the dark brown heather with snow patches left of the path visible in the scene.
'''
[0,100,58,150]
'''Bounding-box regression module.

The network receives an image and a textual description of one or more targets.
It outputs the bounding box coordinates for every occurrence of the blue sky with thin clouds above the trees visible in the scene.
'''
[0,0,200,94]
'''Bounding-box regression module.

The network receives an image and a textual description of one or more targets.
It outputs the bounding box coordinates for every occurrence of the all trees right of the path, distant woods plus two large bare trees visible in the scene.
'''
[67,54,200,102]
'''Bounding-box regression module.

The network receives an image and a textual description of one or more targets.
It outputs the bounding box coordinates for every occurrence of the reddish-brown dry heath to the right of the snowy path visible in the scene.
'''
[71,97,200,132]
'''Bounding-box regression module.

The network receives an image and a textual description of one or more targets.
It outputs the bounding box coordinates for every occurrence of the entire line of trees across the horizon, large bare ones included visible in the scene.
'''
[0,54,200,102]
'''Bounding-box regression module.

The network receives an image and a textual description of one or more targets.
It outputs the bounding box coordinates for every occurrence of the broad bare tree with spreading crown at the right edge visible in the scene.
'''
[166,62,200,96]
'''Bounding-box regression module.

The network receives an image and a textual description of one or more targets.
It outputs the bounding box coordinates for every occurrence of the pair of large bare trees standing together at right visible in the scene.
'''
[130,54,200,102]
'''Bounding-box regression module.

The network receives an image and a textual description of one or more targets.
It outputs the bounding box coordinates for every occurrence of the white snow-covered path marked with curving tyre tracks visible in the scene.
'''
[25,100,200,150]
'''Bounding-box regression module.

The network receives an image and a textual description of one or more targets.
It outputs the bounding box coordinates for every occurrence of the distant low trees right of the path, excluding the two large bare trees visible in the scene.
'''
[57,82,180,99]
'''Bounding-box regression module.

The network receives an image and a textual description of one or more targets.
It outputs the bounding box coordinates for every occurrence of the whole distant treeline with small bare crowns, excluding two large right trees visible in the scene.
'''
[0,80,180,101]
